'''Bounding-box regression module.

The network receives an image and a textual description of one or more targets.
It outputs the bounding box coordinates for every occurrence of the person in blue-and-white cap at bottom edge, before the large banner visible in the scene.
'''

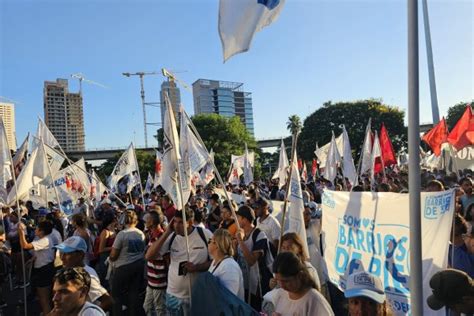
[344,271,389,316]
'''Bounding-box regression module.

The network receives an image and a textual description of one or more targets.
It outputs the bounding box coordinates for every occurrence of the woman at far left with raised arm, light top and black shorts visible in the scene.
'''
[18,221,55,315]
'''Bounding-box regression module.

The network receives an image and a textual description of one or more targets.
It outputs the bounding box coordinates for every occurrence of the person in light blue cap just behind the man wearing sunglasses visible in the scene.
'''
[54,236,113,311]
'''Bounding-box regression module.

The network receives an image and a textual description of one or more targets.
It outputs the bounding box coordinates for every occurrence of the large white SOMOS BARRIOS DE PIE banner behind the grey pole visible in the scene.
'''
[322,190,454,315]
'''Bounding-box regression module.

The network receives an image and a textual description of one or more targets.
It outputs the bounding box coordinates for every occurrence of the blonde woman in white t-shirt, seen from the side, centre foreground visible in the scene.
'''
[209,228,244,300]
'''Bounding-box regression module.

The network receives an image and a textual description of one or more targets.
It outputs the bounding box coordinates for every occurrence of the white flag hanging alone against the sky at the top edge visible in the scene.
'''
[219,0,285,62]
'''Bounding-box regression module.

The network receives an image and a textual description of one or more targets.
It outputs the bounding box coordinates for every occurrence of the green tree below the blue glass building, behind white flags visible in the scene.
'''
[191,114,261,181]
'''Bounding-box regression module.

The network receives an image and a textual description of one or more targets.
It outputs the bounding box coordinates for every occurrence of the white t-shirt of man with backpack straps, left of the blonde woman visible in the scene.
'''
[160,228,212,299]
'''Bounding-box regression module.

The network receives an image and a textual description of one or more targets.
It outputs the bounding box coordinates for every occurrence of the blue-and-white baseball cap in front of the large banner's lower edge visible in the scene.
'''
[344,271,385,304]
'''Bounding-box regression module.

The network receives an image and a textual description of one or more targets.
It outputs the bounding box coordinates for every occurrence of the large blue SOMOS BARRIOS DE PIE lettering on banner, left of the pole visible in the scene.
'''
[333,215,410,304]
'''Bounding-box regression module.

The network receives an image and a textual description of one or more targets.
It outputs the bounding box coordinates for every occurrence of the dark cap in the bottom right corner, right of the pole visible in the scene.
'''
[426,269,474,310]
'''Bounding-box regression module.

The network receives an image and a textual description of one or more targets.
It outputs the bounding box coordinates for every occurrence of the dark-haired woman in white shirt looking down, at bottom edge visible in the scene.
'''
[272,252,334,316]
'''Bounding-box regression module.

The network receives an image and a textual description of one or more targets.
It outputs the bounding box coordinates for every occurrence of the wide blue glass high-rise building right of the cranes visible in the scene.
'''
[193,79,254,135]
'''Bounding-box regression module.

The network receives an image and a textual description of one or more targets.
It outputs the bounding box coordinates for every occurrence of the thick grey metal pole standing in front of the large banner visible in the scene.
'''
[407,0,423,316]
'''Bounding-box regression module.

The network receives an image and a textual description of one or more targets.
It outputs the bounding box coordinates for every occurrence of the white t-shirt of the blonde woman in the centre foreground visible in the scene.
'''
[209,257,245,300]
